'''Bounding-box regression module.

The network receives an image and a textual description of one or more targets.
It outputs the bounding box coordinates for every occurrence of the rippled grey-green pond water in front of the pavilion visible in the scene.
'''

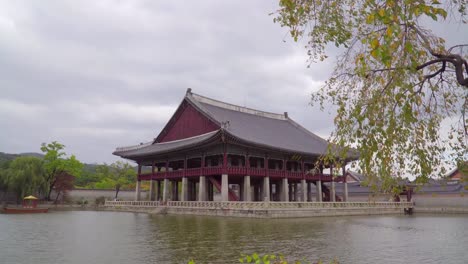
[0,211,468,264]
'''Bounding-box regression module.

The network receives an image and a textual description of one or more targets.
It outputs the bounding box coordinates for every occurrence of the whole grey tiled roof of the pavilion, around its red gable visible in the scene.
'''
[114,89,356,159]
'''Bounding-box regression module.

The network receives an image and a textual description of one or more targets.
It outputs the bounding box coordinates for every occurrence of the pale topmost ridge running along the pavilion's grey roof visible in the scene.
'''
[187,92,288,120]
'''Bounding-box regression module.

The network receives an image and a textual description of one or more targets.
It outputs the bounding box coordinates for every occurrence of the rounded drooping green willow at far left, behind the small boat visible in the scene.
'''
[0,157,47,202]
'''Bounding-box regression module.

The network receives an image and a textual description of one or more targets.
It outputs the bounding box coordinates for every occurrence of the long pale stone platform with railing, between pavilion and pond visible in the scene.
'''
[105,201,413,218]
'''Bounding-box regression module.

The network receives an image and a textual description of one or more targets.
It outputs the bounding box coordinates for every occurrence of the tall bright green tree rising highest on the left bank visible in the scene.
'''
[41,141,83,201]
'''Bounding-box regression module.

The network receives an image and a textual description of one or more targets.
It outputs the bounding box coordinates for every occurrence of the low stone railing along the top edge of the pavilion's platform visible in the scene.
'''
[105,201,414,209]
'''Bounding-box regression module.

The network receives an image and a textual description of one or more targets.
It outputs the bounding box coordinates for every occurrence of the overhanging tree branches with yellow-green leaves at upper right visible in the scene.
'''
[274,0,468,190]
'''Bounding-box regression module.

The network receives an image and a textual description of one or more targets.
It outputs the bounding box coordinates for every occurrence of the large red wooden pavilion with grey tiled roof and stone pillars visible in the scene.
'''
[113,88,357,202]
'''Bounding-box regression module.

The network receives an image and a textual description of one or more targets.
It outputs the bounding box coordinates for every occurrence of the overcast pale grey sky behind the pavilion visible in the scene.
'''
[0,0,468,163]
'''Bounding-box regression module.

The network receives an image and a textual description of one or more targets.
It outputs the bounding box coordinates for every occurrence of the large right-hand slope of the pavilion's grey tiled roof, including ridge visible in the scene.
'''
[187,93,357,158]
